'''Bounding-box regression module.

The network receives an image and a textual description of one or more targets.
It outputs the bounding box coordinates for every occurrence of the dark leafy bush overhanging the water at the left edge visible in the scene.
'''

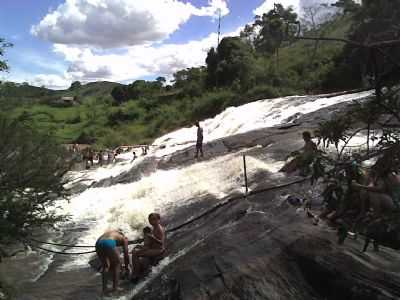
[0,114,69,241]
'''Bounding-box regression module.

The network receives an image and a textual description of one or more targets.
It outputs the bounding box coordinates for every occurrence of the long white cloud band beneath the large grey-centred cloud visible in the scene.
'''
[54,33,217,81]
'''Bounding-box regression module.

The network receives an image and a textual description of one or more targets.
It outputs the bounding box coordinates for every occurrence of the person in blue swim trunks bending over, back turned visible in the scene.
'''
[96,230,129,294]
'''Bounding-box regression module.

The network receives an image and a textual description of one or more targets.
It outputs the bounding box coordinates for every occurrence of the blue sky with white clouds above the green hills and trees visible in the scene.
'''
[0,0,338,89]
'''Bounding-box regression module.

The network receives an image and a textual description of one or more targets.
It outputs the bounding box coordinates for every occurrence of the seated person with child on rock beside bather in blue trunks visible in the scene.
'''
[131,213,166,283]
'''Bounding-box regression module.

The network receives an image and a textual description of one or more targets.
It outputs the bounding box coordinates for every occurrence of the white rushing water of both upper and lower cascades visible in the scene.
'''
[23,92,371,298]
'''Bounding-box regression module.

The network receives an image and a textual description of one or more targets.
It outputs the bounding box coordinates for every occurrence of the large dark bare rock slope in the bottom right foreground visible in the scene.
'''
[132,180,400,300]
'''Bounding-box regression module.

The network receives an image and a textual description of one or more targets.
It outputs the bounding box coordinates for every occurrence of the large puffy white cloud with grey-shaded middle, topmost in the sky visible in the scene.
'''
[31,0,229,48]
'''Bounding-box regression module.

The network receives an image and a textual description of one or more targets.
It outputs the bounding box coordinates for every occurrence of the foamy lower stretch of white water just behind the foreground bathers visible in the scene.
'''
[59,154,282,271]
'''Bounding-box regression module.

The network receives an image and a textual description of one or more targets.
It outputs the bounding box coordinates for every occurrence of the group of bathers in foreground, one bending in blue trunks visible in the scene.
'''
[96,213,166,293]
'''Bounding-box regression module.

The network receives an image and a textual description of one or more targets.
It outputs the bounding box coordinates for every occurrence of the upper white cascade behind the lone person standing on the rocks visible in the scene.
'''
[154,91,372,156]
